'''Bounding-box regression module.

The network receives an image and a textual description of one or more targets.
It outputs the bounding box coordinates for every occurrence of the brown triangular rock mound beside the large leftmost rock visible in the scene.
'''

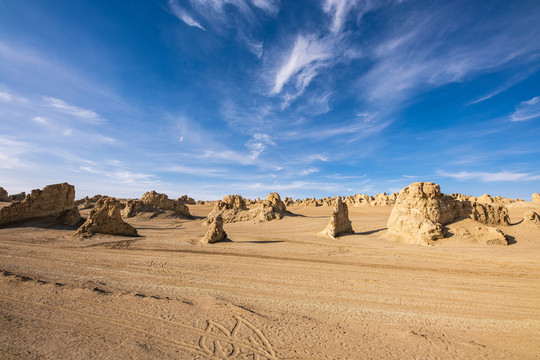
[75,196,138,237]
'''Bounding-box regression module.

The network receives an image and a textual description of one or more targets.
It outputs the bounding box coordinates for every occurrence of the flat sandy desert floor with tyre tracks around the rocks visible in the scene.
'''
[0,202,540,359]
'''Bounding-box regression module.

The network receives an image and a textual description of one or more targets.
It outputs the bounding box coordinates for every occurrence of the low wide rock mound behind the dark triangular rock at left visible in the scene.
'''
[122,191,192,219]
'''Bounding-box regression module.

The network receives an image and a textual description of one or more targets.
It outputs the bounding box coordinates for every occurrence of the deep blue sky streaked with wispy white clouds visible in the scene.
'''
[0,0,540,199]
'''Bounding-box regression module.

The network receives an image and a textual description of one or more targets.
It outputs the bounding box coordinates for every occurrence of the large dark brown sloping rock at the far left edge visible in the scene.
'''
[0,183,80,226]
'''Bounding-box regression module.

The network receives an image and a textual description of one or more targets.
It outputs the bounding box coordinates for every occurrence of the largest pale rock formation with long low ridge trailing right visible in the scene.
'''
[387,182,510,245]
